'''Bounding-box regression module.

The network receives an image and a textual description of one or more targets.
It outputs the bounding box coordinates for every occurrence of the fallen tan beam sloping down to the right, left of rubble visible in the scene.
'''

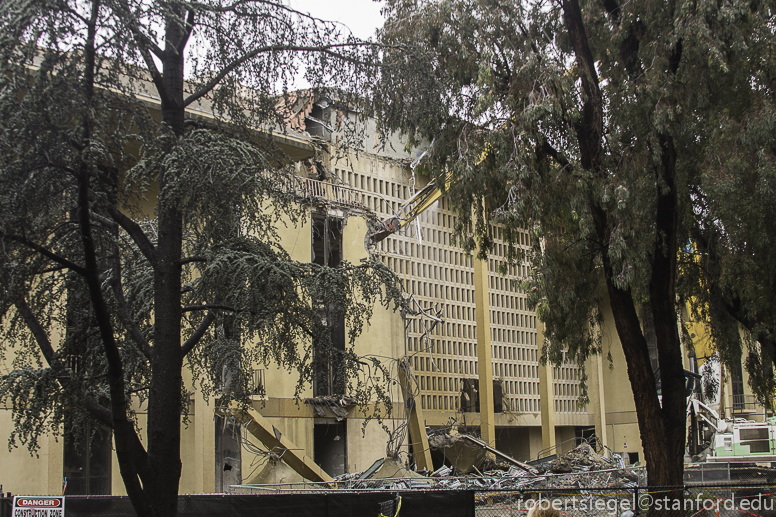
[216,401,333,483]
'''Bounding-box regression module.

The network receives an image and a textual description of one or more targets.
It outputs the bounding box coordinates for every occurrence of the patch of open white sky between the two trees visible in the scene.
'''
[287,0,383,39]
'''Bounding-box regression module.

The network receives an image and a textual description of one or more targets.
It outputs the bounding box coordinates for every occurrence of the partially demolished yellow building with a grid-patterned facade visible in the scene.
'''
[0,92,764,494]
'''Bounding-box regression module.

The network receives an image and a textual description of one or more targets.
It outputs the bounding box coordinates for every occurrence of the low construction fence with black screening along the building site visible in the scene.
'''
[0,485,776,517]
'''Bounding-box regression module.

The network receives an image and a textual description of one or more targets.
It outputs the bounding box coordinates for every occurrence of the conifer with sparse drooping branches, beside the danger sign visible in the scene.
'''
[0,0,401,516]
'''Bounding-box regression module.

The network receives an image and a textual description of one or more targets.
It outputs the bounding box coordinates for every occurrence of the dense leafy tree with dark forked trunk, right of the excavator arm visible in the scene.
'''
[374,0,776,513]
